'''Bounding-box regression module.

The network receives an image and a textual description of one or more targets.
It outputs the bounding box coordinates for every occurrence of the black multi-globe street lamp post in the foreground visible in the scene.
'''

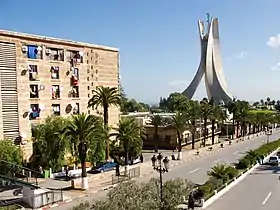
[151,153,170,205]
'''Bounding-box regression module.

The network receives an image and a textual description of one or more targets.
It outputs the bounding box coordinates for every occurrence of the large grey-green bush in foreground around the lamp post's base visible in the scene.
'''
[73,179,193,210]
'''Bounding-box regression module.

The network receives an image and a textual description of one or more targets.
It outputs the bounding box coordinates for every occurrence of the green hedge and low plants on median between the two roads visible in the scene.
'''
[199,139,280,200]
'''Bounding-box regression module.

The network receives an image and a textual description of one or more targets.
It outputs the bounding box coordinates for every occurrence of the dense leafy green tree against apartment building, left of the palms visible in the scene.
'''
[32,117,68,171]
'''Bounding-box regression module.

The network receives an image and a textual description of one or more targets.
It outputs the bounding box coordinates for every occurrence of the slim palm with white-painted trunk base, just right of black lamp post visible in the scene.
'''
[171,112,188,160]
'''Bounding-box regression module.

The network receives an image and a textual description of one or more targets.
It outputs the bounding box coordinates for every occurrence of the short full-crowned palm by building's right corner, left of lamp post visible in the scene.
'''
[112,117,145,174]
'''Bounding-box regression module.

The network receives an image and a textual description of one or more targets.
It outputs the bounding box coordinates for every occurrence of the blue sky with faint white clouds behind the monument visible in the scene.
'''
[0,0,280,103]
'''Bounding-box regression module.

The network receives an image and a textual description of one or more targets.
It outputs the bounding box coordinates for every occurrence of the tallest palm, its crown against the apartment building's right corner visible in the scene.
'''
[88,86,122,160]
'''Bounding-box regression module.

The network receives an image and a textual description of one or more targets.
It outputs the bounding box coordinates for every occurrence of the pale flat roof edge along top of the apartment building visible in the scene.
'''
[0,29,119,52]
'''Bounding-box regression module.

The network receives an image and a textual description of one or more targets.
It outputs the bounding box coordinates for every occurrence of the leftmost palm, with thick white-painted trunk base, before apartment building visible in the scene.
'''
[63,113,102,190]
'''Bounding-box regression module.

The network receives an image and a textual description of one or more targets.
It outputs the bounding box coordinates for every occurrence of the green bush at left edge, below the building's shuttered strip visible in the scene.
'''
[0,140,22,165]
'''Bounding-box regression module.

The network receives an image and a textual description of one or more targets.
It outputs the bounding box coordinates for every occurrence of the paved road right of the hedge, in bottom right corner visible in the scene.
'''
[207,165,280,210]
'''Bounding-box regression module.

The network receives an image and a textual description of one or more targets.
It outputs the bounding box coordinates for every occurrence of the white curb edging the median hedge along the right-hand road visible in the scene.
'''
[200,147,280,209]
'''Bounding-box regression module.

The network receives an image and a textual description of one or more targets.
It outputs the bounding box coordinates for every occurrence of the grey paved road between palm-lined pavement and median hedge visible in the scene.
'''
[51,131,280,210]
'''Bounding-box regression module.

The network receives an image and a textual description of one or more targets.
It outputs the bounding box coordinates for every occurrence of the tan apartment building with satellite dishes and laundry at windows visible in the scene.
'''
[0,30,119,158]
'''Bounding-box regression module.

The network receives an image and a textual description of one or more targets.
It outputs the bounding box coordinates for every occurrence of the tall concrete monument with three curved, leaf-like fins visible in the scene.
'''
[182,13,233,103]
